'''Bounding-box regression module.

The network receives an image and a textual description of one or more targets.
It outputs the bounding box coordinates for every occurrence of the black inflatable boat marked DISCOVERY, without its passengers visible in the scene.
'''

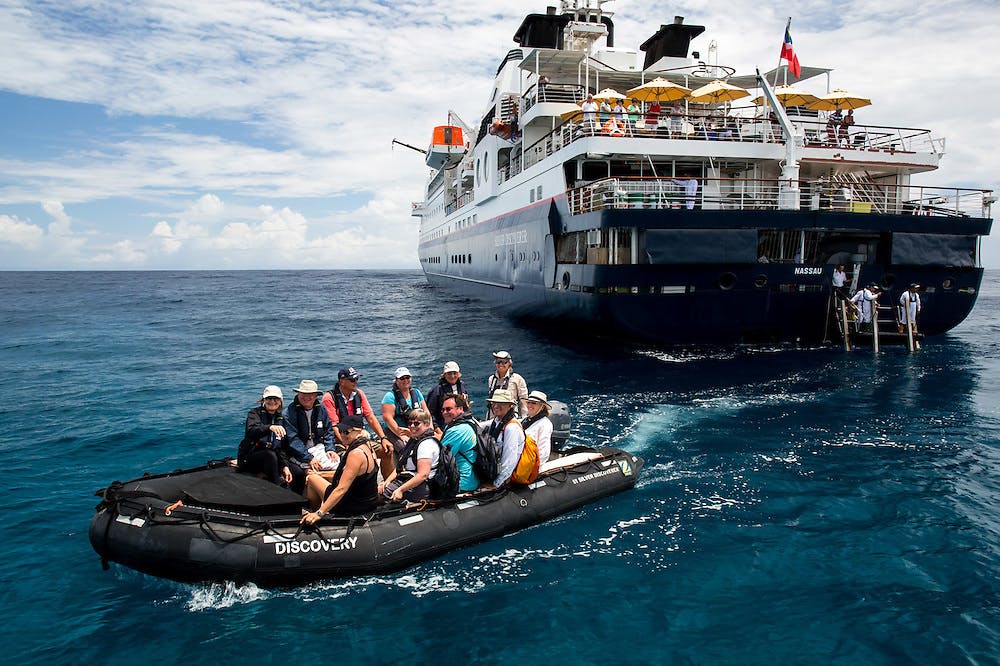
[90,447,643,586]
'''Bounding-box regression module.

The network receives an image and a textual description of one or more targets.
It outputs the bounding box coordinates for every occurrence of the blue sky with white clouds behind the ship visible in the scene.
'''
[0,0,1000,270]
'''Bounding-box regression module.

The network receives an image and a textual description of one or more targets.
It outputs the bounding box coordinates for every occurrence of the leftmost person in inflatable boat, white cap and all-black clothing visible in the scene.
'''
[236,385,292,485]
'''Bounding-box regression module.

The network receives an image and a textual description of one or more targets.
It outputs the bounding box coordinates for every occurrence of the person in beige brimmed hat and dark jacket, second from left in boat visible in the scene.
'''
[285,379,337,493]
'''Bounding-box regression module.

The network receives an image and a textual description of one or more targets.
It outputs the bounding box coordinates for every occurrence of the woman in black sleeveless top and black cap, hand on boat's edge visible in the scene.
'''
[301,416,381,525]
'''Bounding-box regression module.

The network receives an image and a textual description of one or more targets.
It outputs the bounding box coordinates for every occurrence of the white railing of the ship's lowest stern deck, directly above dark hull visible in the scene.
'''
[567,176,995,218]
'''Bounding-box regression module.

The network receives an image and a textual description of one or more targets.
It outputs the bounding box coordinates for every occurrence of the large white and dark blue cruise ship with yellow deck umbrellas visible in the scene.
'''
[413,0,994,344]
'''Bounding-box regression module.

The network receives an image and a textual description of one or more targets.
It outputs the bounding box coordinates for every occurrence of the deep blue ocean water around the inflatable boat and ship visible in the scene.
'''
[0,271,1000,664]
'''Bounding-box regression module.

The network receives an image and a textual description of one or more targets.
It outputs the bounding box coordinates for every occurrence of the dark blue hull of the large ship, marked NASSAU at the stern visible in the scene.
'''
[420,199,992,344]
